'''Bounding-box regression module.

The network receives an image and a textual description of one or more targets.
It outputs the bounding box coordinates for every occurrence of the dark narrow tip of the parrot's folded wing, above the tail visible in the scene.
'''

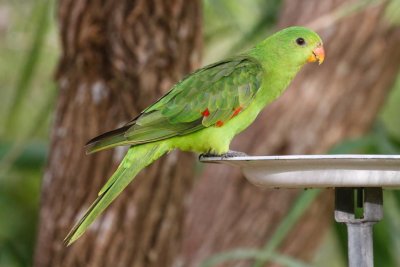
[85,126,130,154]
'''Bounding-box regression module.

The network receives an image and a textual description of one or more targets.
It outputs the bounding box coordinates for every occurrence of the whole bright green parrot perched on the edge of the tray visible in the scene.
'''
[65,27,325,245]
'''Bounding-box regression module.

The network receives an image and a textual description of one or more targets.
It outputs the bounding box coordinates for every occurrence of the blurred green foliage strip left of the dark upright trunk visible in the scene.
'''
[0,0,58,267]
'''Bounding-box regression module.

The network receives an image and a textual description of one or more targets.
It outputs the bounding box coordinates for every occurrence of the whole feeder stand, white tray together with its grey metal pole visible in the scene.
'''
[200,155,400,267]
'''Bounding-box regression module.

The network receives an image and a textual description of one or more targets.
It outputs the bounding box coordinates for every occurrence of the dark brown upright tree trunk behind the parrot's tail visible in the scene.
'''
[35,0,202,267]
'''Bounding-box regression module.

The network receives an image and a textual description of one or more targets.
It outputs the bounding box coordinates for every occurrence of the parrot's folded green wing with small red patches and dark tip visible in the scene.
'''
[88,56,264,152]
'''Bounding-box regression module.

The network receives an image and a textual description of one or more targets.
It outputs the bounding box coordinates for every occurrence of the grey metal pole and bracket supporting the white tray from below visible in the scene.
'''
[335,188,383,267]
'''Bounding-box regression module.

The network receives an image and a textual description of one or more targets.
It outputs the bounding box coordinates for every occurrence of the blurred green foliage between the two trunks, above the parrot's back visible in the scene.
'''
[203,0,282,63]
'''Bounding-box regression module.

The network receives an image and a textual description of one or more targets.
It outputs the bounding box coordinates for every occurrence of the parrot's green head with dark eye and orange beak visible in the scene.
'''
[265,26,325,67]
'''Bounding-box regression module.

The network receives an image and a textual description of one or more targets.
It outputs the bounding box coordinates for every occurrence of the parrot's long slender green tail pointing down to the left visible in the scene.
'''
[64,141,171,245]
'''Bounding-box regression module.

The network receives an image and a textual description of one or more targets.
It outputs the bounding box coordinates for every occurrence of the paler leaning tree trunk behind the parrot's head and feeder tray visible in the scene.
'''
[180,0,400,266]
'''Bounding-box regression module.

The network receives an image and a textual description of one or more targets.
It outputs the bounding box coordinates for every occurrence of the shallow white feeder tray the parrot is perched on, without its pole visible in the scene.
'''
[200,155,400,188]
